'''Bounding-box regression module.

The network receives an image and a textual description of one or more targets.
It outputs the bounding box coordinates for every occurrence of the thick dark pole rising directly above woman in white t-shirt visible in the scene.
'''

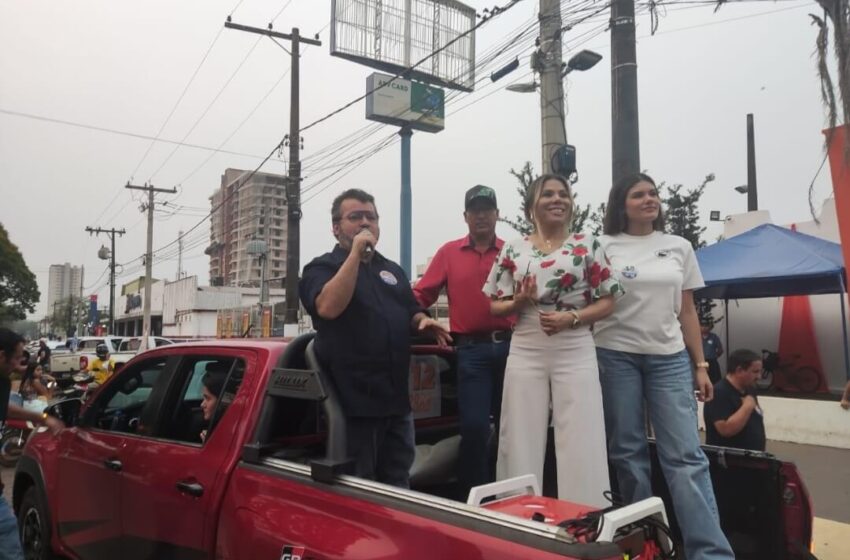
[611,0,640,183]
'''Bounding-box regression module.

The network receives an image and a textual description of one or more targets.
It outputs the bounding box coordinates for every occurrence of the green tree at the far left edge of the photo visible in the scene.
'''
[0,224,41,324]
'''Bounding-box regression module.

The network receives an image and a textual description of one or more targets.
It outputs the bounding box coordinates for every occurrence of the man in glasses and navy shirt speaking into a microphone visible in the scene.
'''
[299,189,451,487]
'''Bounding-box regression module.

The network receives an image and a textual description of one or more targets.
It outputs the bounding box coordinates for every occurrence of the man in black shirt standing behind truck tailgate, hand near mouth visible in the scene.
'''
[703,350,766,451]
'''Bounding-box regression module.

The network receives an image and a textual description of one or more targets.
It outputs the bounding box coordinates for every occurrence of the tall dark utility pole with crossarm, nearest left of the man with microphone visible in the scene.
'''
[224,18,322,336]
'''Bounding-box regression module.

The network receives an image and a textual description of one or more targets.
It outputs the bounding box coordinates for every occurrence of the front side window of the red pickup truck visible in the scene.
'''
[86,358,171,435]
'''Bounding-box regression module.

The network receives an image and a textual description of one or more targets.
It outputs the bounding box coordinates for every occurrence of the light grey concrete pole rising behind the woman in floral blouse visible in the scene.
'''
[533,0,567,173]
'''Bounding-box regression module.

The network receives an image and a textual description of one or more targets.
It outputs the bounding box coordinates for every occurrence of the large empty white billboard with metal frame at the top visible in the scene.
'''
[330,0,476,91]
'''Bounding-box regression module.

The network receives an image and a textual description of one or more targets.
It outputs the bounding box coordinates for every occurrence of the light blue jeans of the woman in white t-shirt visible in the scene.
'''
[596,348,734,560]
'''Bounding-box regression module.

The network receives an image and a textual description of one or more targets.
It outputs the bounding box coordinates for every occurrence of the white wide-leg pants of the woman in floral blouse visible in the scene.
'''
[496,320,610,507]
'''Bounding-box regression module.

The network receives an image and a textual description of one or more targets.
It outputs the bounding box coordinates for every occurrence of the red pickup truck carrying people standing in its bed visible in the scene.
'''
[13,335,812,560]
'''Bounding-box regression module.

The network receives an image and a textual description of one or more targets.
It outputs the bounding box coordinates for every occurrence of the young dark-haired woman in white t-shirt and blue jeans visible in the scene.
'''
[594,173,734,560]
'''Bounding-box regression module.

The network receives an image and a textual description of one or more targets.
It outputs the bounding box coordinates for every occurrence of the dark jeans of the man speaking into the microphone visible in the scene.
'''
[346,413,416,488]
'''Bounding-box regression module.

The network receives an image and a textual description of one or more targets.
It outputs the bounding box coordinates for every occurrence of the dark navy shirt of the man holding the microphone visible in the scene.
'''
[299,245,422,417]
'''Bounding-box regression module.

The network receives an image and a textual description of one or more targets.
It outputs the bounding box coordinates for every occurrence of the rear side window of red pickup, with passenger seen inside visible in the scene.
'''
[159,356,245,444]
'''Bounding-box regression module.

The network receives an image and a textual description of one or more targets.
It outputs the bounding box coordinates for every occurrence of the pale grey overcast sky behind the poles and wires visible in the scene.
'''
[0,0,831,316]
